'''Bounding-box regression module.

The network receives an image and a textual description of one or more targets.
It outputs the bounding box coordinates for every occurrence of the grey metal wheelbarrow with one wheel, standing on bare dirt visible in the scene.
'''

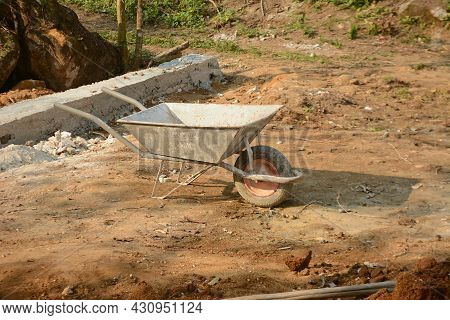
[54,88,302,207]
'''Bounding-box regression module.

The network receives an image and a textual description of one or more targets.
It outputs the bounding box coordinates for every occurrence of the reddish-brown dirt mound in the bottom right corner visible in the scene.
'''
[368,257,450,300]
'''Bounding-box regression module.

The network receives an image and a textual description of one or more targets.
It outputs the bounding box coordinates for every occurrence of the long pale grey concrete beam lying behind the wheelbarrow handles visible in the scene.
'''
[0,54,222,148]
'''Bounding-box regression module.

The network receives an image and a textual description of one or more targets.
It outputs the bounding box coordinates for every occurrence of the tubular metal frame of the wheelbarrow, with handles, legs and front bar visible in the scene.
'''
[54,87,302,199]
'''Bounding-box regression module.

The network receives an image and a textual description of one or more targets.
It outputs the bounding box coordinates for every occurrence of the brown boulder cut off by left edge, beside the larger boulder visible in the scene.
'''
[0,25,20,88]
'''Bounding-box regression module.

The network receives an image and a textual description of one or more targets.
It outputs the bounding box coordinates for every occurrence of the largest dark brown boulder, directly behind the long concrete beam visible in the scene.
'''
[10,0,121,91]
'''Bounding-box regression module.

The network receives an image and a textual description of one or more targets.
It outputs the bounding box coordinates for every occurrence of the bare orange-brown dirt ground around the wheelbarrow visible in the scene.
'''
[0,1,450,299]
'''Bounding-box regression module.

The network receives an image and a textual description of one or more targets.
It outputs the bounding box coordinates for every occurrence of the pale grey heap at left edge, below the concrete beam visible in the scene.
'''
[0,144,56,172]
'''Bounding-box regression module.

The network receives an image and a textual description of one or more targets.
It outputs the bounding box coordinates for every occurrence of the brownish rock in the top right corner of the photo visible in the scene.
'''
[398,0,448,22]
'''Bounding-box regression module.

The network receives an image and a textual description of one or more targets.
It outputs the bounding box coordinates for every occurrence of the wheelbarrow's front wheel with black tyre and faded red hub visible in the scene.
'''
[233,146,292,208]
